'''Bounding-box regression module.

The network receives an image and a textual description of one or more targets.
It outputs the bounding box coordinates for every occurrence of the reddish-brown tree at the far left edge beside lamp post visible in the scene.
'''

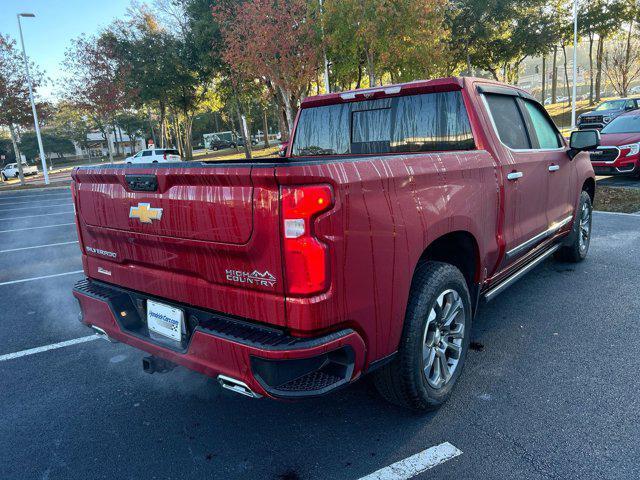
[0,34,43,184]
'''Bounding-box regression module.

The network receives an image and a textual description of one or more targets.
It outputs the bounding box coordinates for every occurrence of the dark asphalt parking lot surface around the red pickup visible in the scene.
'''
[0,189,640,480]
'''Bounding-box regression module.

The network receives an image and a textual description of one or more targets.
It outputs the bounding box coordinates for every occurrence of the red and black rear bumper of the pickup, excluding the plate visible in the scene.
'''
[73,279,365,398]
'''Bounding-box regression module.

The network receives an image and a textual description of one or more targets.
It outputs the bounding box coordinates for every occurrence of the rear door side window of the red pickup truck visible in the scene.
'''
[485,93,531,150]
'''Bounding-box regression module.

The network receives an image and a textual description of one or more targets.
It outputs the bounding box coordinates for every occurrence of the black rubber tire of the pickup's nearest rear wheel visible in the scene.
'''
[373,262,472,411]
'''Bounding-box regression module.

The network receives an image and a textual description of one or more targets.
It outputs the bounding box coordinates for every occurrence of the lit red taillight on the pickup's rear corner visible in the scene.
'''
[281,185,333,295]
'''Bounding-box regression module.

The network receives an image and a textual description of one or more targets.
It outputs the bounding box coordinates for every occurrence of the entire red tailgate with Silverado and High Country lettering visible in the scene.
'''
[73,163,285,325]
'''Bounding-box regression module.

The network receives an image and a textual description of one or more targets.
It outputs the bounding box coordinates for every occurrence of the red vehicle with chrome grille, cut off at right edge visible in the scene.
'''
[591,111,640,175]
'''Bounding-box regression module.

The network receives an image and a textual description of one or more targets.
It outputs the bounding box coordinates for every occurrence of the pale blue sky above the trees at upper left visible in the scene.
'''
[0,0,131,98]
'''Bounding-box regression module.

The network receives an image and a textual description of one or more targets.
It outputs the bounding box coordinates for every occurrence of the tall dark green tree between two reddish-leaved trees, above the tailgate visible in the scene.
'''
[103,0,219,159]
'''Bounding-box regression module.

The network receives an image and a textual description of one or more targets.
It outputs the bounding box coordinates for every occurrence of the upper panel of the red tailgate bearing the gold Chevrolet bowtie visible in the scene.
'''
[77,169,253,244]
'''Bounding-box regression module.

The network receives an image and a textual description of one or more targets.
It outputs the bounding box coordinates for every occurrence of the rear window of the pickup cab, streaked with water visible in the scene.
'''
[293,91,475,156]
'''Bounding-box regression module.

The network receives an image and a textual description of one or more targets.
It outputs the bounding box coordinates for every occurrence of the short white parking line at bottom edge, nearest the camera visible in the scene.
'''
[359,442,462,480]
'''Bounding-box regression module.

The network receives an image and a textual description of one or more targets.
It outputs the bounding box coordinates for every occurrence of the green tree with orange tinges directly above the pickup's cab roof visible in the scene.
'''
[324,0,452,89]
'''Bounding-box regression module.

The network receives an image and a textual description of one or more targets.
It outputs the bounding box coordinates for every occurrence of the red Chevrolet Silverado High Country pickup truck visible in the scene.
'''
[72,78,599,410]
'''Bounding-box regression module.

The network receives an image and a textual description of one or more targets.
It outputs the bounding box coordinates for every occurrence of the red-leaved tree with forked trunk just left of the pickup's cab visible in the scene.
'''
[213,0,321,133]
